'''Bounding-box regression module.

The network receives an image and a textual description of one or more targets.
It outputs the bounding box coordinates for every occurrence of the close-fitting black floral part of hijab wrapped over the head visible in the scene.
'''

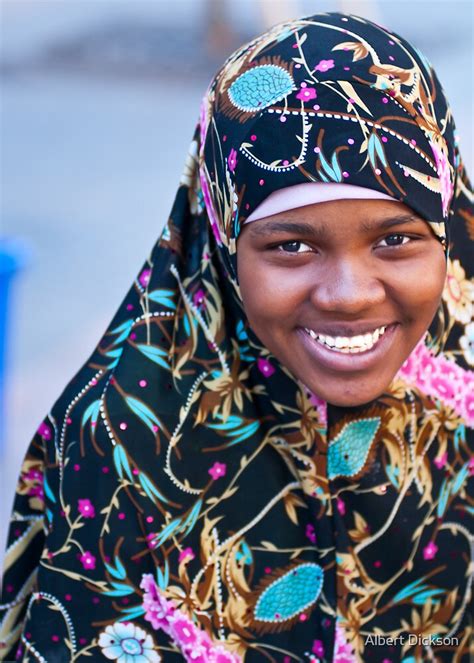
[200,14,466,255]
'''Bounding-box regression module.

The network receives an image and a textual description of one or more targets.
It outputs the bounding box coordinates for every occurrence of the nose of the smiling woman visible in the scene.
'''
[311,257,386,316]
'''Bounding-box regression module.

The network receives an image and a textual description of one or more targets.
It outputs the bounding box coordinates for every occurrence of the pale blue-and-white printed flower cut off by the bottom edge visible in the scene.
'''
[99,622,161,663]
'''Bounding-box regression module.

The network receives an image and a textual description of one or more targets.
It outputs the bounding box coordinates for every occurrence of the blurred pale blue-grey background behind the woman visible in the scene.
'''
[0,0,474,555]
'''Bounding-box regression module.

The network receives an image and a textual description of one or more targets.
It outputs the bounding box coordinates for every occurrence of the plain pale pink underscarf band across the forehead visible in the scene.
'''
[244,182,399,223]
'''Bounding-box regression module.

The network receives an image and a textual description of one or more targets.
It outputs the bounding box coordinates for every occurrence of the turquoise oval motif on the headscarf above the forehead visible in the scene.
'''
[228,64,296,113]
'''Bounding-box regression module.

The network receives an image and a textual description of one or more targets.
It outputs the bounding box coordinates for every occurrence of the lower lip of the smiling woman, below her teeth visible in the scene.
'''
[297,323,398,373]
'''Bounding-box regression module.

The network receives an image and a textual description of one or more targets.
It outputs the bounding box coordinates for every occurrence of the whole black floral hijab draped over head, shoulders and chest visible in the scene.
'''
[0,13,474,663]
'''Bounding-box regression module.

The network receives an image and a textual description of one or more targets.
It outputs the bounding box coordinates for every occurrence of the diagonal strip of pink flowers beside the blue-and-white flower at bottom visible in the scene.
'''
[140,574,241,663]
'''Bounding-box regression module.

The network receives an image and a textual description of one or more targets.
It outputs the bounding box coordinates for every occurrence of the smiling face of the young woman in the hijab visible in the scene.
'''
[237,200,446,406]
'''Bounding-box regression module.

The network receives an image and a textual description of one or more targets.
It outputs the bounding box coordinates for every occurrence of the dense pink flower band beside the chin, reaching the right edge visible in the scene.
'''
[398,340,474,426]
